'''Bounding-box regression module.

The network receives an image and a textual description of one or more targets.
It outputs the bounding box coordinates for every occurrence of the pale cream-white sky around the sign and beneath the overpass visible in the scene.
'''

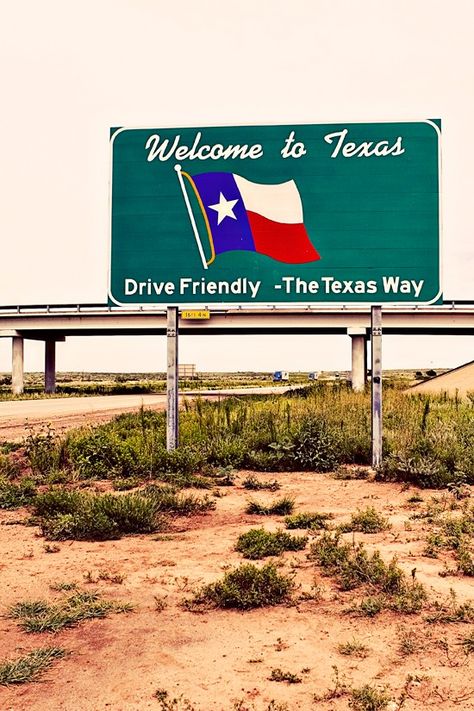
[0,0,474,371]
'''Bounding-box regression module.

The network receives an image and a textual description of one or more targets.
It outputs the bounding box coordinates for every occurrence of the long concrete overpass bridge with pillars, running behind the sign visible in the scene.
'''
[0,301,474,394]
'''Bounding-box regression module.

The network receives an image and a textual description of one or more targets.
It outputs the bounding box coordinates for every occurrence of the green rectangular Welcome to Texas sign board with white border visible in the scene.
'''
[109,120,441,308]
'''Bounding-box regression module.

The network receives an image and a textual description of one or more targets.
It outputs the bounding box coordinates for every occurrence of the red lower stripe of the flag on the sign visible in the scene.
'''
[247,211,321,264]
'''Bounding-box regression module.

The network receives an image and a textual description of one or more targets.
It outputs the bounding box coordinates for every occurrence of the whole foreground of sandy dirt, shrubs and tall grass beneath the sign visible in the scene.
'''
[0,383,474,711]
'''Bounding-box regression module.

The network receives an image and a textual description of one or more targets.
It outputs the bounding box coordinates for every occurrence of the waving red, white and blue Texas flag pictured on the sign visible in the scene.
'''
[181,171,320,266]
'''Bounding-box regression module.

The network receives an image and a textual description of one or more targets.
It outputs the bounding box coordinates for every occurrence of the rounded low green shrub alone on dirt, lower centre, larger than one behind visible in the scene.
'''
[187,563,294,610]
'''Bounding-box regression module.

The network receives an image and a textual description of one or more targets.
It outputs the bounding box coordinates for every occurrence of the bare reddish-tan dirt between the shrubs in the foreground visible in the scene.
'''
[0,472,474,711]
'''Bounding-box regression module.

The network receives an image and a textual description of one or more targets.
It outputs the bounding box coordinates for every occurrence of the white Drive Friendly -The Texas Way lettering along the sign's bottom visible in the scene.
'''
[124,275,425,299]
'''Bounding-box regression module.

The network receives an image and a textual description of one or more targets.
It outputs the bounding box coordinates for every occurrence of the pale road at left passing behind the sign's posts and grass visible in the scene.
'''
[0,386,301,442]
